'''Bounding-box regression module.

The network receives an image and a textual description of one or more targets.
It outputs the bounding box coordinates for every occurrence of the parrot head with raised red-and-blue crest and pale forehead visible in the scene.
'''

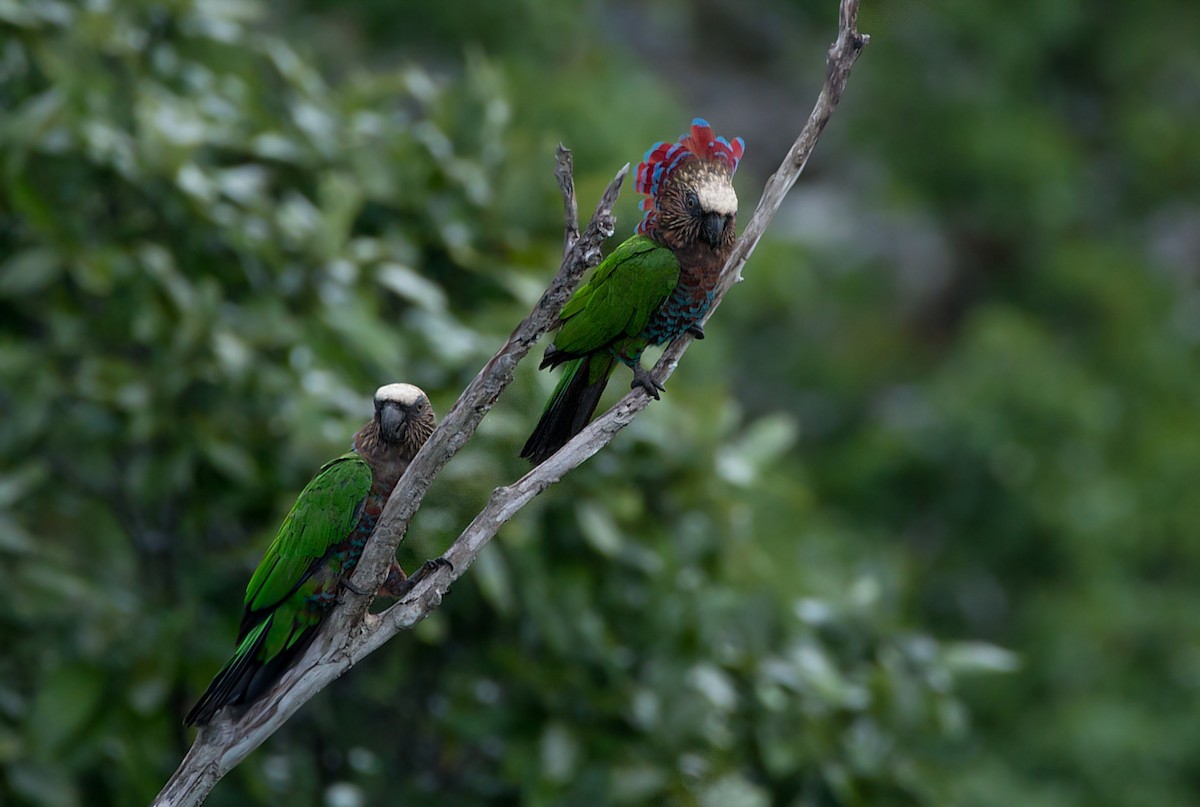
[635,118,745,251]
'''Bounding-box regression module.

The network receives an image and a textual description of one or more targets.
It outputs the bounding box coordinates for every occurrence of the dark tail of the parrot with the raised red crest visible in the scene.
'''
[521,353,617,465]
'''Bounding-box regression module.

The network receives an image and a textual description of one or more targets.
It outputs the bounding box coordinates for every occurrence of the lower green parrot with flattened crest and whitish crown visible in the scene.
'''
[184,384,437,725]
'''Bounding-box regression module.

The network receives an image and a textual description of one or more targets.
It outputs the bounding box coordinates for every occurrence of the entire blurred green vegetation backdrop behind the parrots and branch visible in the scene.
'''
[0,0,1200,807]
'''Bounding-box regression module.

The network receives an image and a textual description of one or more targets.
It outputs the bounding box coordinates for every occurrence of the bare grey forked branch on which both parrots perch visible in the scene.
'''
[154,0,868,807]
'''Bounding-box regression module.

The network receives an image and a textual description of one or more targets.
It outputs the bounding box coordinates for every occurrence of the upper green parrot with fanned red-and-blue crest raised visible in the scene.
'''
[521,118,745,465]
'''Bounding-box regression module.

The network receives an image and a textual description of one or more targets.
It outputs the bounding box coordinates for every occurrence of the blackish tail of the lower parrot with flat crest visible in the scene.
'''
[184,614,317,725]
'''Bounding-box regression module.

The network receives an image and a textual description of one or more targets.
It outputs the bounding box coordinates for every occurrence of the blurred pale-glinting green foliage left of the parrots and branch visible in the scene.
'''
[0,2,540,805]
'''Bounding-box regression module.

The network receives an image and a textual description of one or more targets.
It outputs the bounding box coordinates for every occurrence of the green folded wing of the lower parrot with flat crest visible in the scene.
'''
[246,452,371,611]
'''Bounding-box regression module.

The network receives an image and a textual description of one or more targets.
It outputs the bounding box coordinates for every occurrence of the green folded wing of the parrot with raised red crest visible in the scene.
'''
[554,235,679,354]
